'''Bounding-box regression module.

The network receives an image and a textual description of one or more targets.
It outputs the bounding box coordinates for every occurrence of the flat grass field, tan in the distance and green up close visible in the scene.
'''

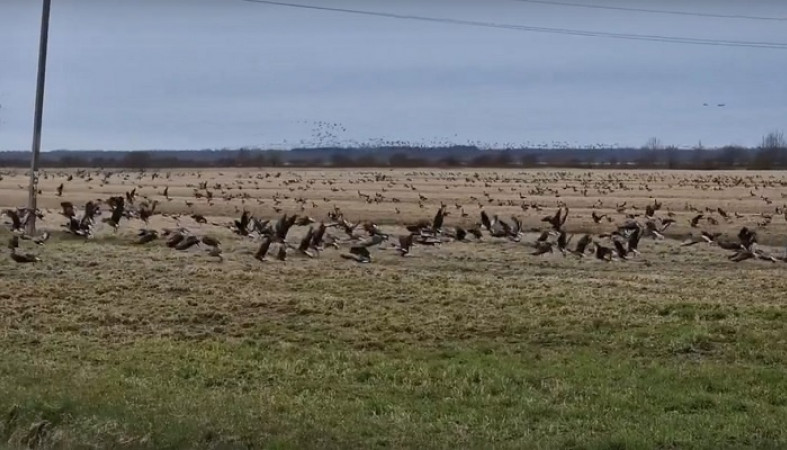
[0,169,787,449]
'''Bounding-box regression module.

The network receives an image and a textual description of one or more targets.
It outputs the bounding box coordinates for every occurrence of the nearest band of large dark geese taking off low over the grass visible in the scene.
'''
[4,192,787,263]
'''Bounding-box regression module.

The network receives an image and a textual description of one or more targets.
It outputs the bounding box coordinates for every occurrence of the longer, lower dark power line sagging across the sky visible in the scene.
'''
[241,0,787,50]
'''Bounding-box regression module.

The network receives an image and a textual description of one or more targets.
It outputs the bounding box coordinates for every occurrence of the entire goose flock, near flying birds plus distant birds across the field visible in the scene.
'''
[0,170,787,263]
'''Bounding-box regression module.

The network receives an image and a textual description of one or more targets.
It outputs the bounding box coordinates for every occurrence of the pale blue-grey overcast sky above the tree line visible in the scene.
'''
[0,0,787,150]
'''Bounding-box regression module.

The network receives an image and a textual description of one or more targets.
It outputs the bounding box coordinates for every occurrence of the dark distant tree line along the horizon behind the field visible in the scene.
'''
[0,132,787,170]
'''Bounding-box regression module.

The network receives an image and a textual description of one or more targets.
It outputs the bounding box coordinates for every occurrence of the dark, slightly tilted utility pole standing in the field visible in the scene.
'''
[26,0,52,235]
